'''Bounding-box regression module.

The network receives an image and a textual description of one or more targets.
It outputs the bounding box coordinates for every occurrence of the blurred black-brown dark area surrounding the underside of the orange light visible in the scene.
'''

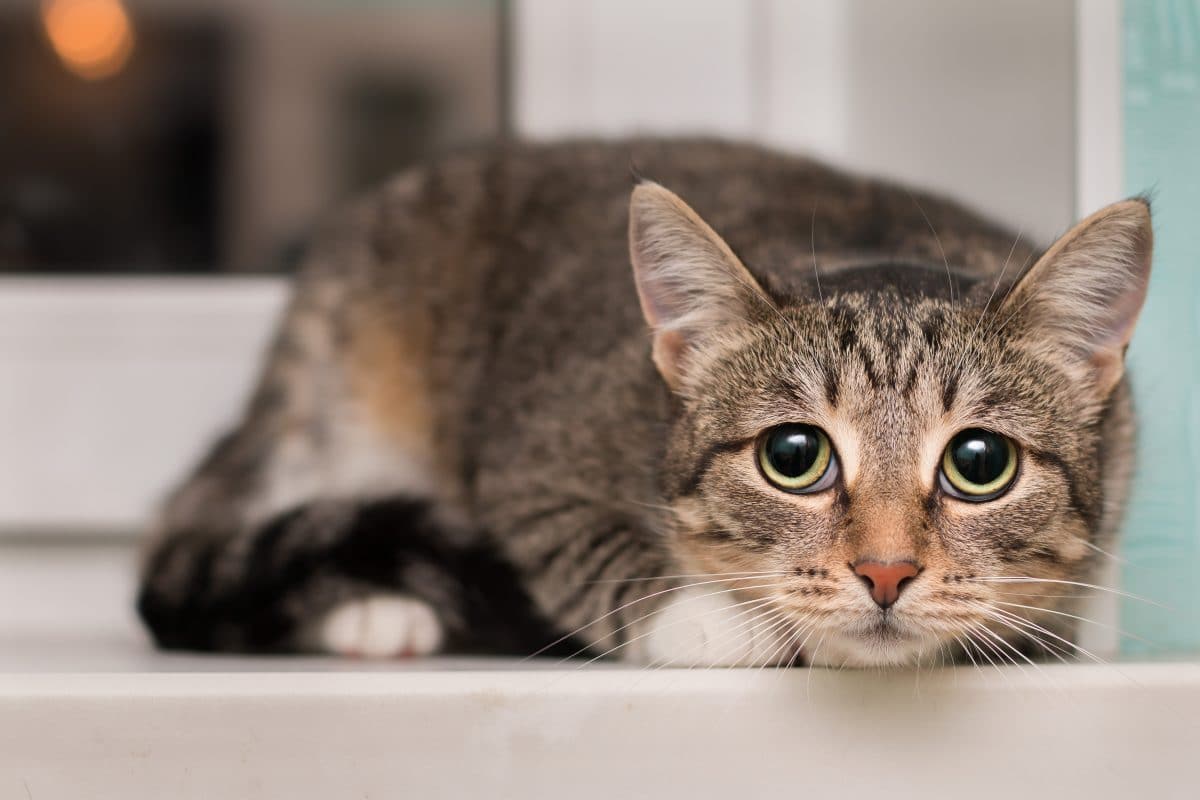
[0,3,230,272]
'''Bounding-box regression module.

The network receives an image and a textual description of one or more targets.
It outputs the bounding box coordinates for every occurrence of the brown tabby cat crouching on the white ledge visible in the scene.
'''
[140,142,1148,663]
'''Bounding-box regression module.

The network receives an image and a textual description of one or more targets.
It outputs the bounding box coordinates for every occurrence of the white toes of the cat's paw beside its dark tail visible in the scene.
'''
[317,595,442,658]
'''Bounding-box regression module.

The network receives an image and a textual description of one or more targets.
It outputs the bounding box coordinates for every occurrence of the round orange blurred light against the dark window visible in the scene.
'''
[42,0,133,80]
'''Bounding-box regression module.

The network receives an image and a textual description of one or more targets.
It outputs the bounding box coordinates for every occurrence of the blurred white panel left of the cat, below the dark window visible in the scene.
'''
[0,278,286,533]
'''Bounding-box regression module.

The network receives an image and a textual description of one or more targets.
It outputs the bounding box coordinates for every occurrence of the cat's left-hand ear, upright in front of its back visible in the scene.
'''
[629,182,770,390]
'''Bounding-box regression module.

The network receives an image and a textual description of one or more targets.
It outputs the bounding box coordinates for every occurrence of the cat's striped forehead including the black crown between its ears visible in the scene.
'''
[697,256,1070,447]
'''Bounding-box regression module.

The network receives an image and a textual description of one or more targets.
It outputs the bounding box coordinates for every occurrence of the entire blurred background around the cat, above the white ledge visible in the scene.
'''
[0,0,1200,650]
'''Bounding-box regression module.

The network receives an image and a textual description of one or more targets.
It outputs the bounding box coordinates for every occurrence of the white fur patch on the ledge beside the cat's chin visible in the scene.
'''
[637,589,798,667]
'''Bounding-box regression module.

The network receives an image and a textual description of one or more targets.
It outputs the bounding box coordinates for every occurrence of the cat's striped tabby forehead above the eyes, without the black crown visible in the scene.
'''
[710,285,1025,435]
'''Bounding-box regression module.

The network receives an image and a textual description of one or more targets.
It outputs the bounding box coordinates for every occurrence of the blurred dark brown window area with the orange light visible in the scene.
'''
[0,0,502,273]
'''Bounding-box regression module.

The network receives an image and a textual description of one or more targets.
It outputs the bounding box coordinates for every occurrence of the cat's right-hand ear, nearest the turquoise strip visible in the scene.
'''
[1000,199,1154,397]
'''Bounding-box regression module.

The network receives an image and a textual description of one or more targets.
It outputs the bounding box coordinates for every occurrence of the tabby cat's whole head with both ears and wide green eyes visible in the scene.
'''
[630,184,1152,664]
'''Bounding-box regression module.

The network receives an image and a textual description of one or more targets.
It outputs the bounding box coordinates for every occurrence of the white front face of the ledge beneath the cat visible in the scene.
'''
[0,664,1200,800]
